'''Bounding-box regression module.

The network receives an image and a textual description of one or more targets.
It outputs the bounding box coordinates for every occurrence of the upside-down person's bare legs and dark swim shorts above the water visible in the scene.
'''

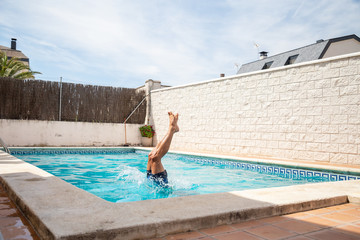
[146,112,179,183]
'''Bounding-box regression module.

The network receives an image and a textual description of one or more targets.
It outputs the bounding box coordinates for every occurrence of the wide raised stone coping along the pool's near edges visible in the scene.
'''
[0,151,360,239]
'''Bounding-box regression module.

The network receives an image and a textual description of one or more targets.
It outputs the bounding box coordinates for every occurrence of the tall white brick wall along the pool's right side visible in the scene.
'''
[151,53,360,165]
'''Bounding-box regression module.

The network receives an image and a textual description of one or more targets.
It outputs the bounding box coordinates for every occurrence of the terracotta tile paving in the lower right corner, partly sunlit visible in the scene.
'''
[152,203,360,240]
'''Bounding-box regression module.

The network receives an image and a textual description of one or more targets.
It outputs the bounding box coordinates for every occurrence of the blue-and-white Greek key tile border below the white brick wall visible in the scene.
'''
[183,157,360,181]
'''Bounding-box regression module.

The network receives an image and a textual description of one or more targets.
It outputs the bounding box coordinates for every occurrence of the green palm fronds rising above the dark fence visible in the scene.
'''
[0,51,41,80]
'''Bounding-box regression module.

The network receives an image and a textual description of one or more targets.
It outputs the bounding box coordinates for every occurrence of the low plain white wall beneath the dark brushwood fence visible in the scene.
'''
[0,119,141,146]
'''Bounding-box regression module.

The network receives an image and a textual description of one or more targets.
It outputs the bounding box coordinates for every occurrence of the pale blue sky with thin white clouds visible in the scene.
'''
[0,0,360,88]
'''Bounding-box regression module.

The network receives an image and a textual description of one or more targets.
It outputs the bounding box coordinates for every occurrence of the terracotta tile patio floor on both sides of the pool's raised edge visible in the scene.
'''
[0,182,360,240]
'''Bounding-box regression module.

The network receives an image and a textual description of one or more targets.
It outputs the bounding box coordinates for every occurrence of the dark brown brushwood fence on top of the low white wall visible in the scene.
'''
[0,78,146,123]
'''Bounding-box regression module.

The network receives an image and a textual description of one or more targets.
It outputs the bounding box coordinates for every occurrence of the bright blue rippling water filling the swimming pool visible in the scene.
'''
[12,149,360,202]
